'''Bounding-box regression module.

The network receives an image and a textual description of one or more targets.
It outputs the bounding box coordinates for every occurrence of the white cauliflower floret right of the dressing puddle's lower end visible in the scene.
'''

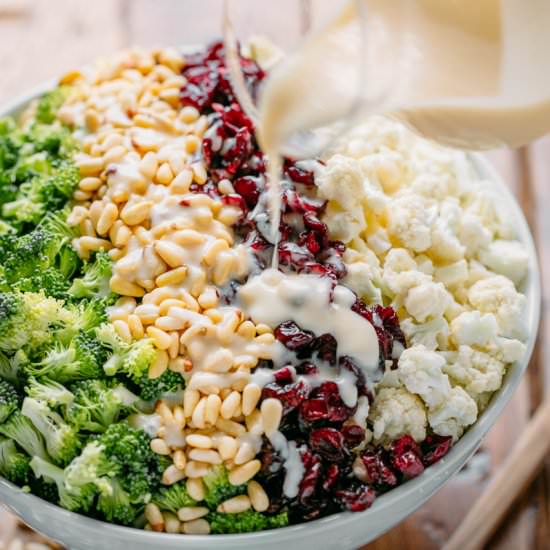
[397,346,451,409]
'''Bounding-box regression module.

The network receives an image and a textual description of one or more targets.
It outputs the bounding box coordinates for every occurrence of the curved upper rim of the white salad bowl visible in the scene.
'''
[0,79,541,550]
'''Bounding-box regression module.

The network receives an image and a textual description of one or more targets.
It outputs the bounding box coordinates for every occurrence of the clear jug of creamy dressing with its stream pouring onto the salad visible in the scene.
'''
[224,0,550,240]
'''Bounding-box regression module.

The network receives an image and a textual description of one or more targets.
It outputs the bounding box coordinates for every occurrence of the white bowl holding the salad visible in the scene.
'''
[0,82,540,550]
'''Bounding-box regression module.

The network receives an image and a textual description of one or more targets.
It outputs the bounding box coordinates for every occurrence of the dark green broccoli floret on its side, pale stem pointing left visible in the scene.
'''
[26,333,107,384]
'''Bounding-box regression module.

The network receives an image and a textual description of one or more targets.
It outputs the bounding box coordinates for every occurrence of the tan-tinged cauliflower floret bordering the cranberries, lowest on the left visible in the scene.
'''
[369,388,432,441]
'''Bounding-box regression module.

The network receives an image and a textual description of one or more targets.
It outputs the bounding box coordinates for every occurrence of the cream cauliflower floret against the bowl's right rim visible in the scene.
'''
[468,275,526,339]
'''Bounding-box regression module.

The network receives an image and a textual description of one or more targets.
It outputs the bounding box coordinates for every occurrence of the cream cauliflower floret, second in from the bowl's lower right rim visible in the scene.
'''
[443,346,506,399]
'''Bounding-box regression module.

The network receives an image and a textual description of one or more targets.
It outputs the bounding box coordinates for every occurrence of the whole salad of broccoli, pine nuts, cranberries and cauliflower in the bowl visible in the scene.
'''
[0,42,529,534]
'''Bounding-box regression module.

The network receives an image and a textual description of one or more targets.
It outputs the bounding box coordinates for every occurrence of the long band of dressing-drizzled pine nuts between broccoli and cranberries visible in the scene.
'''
[58,50,282,534]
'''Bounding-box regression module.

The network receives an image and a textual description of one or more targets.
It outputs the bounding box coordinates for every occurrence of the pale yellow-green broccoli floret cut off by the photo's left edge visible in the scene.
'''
[0,292,66,352]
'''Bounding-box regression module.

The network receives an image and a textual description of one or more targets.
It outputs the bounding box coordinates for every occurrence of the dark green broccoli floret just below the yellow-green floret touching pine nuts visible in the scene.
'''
[67,379,138,433]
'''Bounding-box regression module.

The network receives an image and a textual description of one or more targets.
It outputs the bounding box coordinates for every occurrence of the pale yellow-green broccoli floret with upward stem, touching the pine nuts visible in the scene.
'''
[96,324,157,383]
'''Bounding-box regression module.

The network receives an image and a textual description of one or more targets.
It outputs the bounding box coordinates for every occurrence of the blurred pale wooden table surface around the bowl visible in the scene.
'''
[0,0,550,550]
